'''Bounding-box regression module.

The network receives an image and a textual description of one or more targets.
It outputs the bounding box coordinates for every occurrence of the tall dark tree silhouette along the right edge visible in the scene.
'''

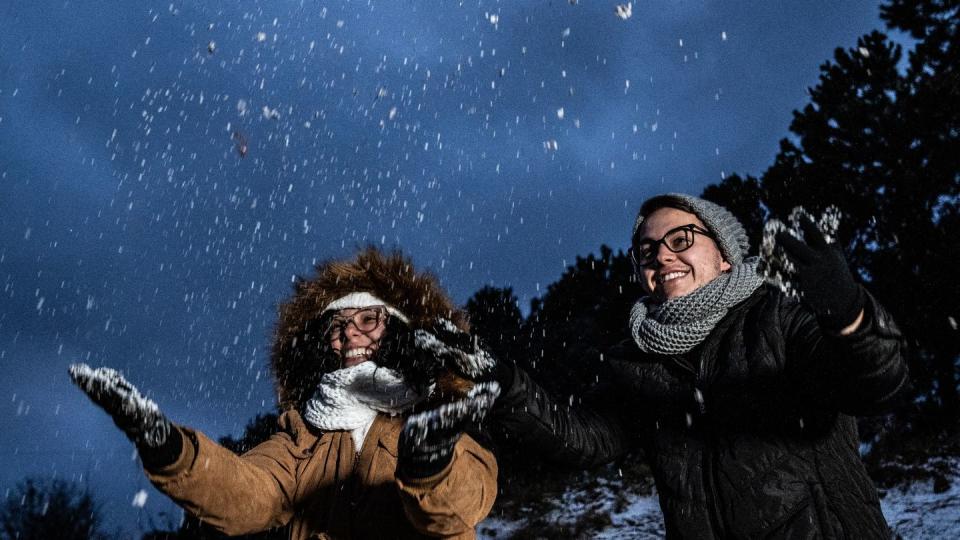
[704,0,960,428]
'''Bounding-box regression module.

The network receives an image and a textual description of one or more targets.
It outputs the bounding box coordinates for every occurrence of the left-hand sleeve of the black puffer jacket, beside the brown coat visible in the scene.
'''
[484,360,626,468]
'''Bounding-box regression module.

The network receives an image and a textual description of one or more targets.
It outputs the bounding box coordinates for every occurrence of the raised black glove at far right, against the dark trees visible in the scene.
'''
[776,216,864,332]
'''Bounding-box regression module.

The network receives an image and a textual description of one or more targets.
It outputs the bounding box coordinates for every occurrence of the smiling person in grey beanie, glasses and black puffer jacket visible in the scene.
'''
[444,194,907,538]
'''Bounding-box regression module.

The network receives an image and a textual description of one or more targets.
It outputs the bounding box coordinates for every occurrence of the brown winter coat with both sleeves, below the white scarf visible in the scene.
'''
[149,411,497,540]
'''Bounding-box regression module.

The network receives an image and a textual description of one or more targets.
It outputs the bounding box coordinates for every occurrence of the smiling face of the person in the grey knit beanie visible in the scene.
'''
[636,207,730,302]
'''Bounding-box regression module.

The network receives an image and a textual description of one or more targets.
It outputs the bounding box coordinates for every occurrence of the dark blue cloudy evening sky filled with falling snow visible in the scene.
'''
[0,0,896,530]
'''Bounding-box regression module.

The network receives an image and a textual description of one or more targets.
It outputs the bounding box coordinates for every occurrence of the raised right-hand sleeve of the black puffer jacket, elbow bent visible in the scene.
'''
[783,293,909,416]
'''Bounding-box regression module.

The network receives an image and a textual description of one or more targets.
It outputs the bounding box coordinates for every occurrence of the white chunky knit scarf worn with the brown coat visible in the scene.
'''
[303,361,426,452]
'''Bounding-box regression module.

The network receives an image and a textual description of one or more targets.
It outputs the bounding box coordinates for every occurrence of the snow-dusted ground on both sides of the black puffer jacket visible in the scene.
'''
[478,458,960,540]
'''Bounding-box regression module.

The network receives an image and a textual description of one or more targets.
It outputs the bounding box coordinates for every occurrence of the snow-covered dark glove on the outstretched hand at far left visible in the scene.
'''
[69,364,183,469]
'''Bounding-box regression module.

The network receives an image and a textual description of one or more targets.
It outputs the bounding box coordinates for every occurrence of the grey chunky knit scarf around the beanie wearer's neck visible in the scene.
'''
[630,257,763,354]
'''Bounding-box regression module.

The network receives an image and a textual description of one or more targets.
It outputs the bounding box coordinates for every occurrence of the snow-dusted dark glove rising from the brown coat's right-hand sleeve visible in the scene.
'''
[397,382,500,478]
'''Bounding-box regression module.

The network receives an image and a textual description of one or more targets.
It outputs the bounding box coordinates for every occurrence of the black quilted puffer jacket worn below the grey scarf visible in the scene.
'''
[494,287,907,538]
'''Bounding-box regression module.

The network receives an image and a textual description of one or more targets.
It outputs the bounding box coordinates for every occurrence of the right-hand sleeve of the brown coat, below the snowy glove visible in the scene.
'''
[396,434,497,538]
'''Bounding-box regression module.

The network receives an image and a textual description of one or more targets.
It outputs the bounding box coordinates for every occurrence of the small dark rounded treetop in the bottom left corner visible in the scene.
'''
[0,478,109,540]
